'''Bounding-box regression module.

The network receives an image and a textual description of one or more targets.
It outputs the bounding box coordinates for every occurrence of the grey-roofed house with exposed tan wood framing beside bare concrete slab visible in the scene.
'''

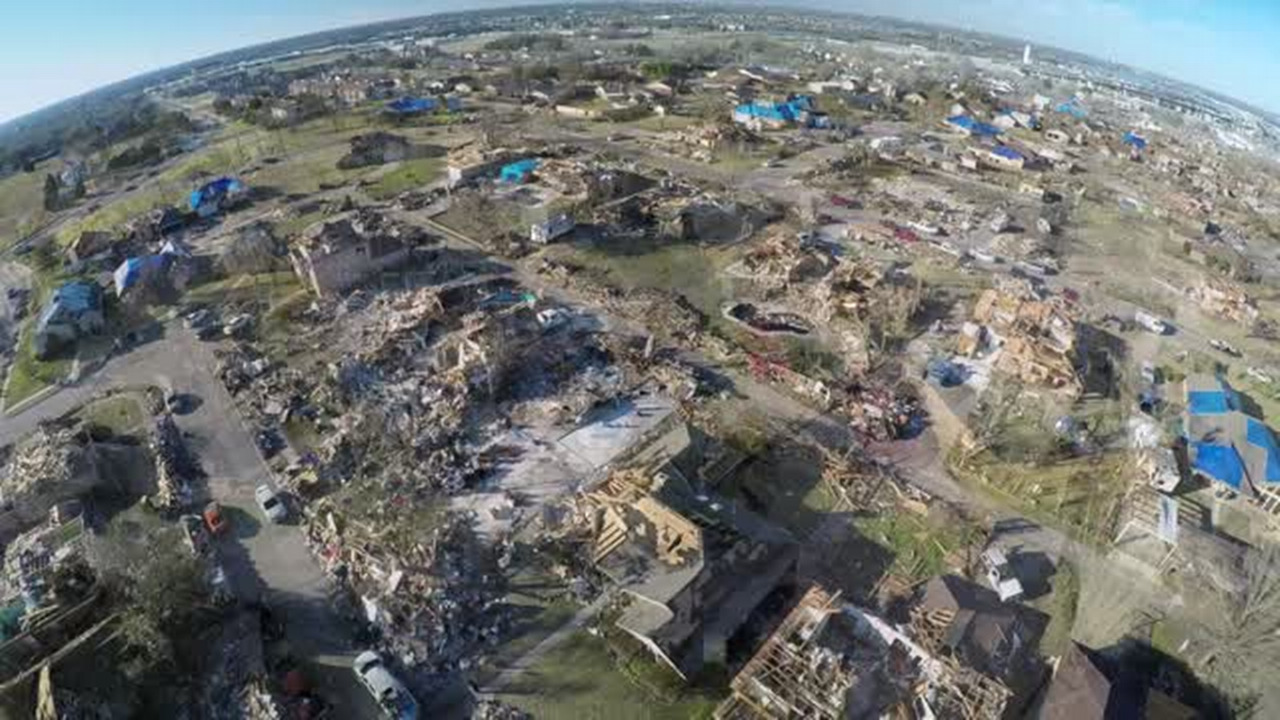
[589,473,797,678]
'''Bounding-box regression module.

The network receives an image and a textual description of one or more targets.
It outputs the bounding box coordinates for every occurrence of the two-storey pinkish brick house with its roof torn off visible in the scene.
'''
[289,210,416,296]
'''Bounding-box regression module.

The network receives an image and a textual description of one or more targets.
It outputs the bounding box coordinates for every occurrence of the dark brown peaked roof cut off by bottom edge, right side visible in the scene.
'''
[1034,642,1199,720]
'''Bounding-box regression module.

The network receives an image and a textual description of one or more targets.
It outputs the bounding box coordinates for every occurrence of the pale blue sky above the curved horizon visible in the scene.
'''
[0,0,1280,122]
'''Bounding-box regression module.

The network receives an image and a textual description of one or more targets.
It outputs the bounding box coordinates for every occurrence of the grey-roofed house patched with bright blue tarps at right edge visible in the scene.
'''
[1184,375,1280,511]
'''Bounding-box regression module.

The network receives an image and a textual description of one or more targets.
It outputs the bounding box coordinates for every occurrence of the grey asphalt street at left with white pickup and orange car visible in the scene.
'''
[0,323,381,720]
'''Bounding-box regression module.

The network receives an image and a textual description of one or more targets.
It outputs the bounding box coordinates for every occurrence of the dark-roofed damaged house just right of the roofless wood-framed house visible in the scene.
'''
[911,575,1043,679]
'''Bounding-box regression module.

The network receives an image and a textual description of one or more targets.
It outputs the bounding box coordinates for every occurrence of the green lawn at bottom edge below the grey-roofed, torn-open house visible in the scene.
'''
[502,632,716,720]
